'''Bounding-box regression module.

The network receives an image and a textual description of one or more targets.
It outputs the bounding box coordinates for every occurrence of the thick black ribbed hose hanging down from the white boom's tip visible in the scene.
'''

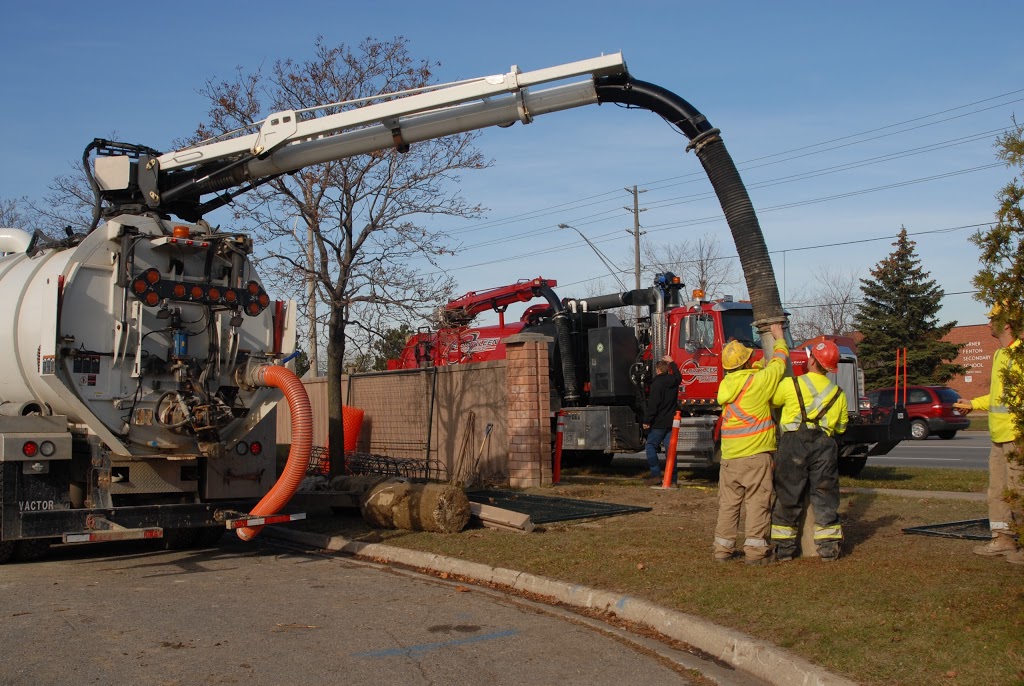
[596,77,785,331]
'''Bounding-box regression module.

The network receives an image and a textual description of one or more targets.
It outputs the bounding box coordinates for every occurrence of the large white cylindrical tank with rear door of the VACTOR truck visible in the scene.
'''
[0,215,295,457]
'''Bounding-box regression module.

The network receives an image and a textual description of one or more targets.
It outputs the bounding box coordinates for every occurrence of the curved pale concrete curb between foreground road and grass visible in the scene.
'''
[264,526,856,686]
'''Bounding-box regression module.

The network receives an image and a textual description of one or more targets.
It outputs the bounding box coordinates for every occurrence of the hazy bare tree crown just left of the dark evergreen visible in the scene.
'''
[787,266,860,341]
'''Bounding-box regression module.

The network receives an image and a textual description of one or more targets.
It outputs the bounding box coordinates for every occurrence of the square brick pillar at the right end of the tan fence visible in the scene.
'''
[505,334,552,488]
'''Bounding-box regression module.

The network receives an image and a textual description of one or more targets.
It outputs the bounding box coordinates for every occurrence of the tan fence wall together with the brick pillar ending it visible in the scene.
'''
[276,334,552,487]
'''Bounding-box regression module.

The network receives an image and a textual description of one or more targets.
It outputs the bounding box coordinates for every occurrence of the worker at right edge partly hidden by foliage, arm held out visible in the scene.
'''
[953,303,1024,564]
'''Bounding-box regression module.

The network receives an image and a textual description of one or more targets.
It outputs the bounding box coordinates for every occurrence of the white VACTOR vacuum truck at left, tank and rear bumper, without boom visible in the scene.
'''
[0,219,308,561]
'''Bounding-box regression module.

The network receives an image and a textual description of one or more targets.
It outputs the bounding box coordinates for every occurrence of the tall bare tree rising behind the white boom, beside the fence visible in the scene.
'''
[198,37,489,470]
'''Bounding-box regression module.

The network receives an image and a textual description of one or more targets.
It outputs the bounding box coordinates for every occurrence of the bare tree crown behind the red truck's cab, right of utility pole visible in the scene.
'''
[640,233,740,297]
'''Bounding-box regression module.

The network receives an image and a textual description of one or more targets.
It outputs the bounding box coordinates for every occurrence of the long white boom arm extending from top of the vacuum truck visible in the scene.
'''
[158,53,626,178]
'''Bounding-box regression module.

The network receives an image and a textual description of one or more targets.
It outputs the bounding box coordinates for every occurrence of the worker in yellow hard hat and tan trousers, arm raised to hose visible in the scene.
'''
[714,324,790,564]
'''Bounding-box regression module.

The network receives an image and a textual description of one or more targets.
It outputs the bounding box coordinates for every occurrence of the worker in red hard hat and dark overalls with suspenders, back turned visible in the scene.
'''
[771,341,849,562]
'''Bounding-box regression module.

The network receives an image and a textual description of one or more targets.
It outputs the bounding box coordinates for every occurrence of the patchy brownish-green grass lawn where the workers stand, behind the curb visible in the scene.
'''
[298,467,1024,686]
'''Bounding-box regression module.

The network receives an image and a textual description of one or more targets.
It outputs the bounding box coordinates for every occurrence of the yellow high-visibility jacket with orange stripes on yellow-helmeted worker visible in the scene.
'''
[718,340,790,460]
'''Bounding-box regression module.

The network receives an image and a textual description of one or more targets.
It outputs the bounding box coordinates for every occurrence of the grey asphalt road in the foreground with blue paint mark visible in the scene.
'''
[0,537,755,686]
